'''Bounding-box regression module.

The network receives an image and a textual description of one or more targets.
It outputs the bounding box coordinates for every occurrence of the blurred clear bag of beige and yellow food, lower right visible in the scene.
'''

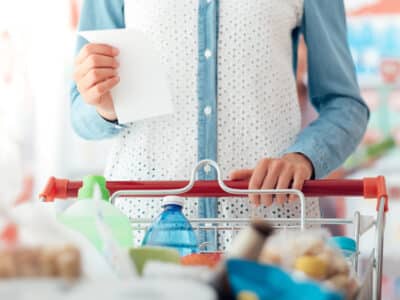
[259,230,359,299]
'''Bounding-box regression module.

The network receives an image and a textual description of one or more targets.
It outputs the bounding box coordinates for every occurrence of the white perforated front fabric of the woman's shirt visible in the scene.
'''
[105,0,320,248]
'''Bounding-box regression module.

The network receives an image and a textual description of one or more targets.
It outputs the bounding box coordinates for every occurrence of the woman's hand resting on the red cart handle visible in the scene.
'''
[230,153,313,206]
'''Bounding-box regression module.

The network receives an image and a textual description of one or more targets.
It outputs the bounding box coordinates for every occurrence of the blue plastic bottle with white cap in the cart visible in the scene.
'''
[142,196,199,256]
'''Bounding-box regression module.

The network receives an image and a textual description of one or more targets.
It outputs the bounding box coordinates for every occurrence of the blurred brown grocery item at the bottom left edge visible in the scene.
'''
[0,245,81,280]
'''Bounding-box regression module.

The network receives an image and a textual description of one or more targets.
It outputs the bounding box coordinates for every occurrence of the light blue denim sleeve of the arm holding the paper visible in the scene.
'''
[70,0,125,140]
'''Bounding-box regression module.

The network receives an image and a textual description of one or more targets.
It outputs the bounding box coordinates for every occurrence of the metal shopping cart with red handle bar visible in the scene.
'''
[40,160,388,300]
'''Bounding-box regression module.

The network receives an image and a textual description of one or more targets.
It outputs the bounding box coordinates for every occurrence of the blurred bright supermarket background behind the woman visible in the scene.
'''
[0,0,400,299]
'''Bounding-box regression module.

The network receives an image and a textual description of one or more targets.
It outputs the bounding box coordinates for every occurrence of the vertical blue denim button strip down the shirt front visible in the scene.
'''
[197,0,218,251]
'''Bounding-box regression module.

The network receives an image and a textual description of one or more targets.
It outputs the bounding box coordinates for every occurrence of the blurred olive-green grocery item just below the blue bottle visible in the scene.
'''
[129,246,180,275]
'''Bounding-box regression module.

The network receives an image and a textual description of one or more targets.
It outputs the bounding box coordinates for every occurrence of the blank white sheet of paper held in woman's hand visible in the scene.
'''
[79,29,173,124]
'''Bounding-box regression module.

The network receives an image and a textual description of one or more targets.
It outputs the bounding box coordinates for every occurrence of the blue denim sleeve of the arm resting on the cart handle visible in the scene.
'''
[285,0,369,178]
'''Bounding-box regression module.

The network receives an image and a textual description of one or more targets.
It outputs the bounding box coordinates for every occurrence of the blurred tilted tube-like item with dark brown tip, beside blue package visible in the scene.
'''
[210,220,274,299]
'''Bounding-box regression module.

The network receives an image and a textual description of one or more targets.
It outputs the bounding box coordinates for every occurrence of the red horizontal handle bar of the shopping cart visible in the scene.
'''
[40,176,389,212]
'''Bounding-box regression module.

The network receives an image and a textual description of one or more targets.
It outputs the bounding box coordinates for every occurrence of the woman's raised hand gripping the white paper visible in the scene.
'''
[74,44,119,121]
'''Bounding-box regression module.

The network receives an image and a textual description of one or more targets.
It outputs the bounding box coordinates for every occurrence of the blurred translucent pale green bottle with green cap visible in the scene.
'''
[58,176,133,251]
